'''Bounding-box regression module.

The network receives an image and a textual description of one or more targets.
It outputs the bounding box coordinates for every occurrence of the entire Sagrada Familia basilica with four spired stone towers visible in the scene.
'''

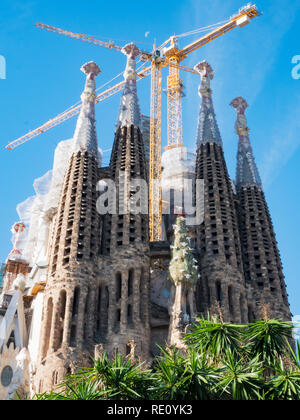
[0,44,291,399]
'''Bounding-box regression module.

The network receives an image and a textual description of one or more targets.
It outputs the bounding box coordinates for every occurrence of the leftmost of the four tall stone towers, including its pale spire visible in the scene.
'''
[35,62,100,392]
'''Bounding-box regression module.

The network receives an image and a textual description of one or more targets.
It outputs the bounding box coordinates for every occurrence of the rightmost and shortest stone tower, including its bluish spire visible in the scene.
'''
[230,97,291,321]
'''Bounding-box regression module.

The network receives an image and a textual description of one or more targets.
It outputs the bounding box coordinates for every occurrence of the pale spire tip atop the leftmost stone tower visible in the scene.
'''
[74,61,101,159]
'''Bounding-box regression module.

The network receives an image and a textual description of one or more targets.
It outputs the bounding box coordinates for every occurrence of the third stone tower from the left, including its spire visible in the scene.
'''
[195,61,247,322]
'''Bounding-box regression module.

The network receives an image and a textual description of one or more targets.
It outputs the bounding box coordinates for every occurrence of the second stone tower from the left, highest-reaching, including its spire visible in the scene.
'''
[100,44,150,360]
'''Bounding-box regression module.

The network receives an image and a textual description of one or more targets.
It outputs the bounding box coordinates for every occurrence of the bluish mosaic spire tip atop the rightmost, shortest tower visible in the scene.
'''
[230,96,261,188]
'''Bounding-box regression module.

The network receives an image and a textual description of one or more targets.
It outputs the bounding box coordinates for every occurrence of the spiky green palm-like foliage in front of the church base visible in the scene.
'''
[35,318,300,400]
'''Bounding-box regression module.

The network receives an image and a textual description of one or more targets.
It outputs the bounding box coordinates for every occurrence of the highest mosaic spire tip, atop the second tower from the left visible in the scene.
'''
[117,43,141,128]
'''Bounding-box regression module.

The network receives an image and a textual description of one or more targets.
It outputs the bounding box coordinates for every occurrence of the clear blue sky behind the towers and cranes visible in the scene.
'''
[0,0,300,315]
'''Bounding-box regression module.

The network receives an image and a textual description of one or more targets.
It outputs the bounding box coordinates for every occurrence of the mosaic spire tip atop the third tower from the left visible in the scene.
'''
[194,61,222,146]
